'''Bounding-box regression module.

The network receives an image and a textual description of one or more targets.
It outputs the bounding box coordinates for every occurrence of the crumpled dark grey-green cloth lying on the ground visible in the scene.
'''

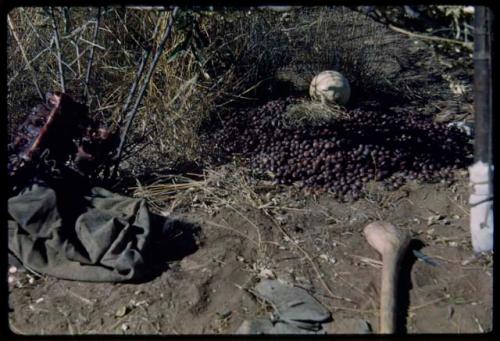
[8,182,151,282]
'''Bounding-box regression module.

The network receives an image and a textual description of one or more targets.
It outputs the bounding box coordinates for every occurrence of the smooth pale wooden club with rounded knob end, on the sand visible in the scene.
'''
[363,221,410,334]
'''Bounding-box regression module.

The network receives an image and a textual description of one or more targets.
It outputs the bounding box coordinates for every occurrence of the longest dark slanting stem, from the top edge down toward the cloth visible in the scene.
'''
[111,6,179,180]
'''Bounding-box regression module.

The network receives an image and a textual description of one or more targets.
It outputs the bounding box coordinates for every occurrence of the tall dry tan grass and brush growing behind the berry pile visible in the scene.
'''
[7,7,414,177]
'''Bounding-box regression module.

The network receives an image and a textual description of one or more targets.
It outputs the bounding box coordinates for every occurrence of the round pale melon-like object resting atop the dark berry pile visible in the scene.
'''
[309,70,351,105]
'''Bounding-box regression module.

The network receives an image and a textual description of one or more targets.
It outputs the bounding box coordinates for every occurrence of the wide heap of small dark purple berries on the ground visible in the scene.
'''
[216,98,473,199]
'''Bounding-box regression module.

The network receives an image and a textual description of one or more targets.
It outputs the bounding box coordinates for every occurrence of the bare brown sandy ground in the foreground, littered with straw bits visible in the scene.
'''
[9,171,492,334]
